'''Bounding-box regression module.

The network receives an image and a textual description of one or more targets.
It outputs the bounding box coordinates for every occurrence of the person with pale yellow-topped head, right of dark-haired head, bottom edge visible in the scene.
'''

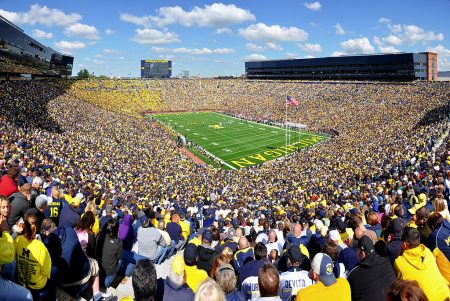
[163,254,194,301]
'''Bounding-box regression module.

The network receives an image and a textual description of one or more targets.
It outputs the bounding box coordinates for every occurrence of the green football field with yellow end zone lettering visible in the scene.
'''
[151,112,328,169]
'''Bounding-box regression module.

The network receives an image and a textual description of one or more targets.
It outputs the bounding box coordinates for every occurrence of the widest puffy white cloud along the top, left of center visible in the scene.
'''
[120,3,256,28]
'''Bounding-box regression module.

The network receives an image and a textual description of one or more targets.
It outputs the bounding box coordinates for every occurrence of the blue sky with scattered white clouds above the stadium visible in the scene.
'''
[0,0,450,77]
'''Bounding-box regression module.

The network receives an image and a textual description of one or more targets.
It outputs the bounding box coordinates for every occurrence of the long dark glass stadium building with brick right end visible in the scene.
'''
[245,52,438,81]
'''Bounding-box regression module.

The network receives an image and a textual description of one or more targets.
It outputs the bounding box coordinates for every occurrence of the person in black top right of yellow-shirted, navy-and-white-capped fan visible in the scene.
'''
[347,235,396,301]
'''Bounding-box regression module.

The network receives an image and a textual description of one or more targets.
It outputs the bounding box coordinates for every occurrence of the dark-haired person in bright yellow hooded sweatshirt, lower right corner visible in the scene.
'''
[394,227,450,300]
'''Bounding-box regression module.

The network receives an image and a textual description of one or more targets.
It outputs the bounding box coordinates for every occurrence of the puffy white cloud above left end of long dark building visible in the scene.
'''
[239,23,308,42]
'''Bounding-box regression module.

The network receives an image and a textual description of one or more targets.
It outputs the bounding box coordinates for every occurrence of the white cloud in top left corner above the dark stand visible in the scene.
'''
[0,4,81,27]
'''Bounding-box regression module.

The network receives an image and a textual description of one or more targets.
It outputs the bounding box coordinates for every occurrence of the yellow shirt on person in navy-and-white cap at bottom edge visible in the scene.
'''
[295,278,352,301]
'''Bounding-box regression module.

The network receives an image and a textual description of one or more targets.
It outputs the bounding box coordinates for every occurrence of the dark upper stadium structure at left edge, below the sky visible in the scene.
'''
[0,16,73,78]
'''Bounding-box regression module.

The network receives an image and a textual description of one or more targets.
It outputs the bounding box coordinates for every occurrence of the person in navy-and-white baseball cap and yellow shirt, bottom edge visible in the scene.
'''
[295,253,352,301]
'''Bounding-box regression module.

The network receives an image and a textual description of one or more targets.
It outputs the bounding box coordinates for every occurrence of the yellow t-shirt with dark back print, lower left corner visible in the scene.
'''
[14,235,52,289]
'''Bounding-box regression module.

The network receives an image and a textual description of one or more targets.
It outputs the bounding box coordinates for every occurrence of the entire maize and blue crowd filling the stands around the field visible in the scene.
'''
[0,79,450,300]
